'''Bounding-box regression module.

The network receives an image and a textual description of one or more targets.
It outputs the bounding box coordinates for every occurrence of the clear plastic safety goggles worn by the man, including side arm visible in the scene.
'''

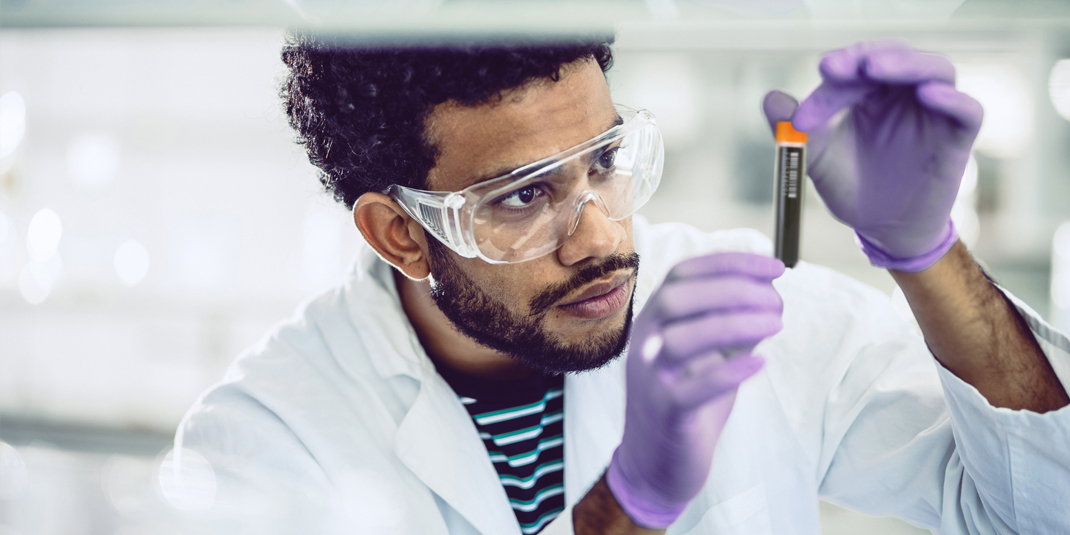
[383,105,664,263]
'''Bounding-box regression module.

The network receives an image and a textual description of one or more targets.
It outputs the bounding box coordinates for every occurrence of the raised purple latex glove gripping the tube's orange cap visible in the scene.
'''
[762,41,982,271]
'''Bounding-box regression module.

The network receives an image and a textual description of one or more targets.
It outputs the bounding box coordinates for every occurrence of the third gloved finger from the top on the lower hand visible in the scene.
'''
[657,311,783,367]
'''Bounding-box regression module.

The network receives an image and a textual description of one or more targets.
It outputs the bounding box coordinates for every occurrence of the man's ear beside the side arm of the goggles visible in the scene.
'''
[353,193,431,280]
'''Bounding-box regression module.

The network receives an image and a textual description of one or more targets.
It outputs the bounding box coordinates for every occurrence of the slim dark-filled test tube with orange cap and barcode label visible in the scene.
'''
[774,121,806,268]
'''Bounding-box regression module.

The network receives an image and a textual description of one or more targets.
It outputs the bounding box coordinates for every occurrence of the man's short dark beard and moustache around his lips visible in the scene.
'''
[427,236,639,375]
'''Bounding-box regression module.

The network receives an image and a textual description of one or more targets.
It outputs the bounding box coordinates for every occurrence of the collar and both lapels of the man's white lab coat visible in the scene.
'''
[346,244,624,535]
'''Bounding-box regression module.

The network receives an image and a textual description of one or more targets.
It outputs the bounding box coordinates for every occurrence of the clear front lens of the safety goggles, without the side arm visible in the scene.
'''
[471,122,662,262]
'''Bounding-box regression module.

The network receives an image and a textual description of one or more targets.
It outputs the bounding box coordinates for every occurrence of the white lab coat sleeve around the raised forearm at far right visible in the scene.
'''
[819,286,1070,535]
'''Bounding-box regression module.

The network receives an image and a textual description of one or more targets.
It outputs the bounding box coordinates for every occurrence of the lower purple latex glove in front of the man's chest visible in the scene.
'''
[606,253,784,528]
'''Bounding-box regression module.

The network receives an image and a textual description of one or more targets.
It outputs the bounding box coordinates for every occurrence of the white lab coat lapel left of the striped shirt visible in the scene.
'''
[394,369,520,535]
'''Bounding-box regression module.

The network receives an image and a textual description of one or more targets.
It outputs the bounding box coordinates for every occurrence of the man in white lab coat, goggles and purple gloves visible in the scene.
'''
[175,37,1070,534]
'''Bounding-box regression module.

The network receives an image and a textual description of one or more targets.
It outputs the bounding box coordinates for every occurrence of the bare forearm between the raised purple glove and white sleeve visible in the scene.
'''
[890,242,1070,413]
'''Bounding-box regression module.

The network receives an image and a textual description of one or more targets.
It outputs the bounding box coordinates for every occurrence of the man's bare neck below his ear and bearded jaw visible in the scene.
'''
[394,270,535,380]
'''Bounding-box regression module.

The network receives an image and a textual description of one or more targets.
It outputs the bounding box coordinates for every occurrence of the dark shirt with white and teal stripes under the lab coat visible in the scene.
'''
[438,366,565,535]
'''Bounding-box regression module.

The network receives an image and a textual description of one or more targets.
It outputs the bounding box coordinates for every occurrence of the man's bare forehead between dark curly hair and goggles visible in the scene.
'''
[427,60,617,192]
